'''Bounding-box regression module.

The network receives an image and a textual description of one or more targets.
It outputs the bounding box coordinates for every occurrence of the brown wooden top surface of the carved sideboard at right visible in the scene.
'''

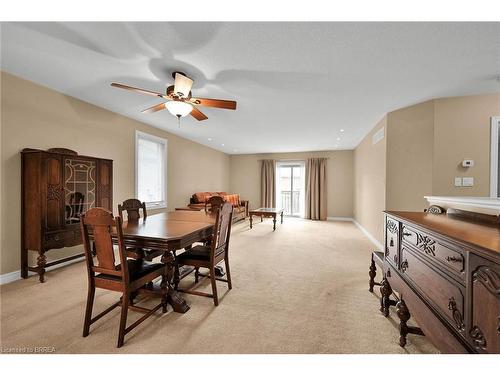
[387,211,500,255]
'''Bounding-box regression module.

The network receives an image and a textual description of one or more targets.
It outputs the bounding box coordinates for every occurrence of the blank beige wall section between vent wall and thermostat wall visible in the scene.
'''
[386,100,434,211]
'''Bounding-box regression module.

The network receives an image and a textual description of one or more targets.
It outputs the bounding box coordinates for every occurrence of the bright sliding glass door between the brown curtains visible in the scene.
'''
[276,162,305,216]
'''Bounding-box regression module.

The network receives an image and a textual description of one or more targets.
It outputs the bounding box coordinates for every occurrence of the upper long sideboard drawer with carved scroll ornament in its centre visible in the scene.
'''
[402,225,465,279]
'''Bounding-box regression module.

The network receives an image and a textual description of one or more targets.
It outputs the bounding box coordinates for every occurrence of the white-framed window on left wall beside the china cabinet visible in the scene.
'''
[135,131,167,208]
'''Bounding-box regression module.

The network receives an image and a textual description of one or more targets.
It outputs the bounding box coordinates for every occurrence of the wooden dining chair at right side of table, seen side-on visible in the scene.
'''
[175,202,233,306]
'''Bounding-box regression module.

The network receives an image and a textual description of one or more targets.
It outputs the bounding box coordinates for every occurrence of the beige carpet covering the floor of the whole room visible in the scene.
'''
[1,218,437,353]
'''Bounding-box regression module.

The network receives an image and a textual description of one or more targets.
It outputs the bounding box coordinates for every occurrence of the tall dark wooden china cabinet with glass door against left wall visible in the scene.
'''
[21,148,113,282]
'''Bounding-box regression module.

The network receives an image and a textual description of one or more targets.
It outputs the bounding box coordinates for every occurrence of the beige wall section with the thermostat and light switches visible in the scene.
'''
[432,94,500,197]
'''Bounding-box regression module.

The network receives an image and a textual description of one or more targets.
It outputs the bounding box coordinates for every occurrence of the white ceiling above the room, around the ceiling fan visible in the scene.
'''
[1,22,500,154]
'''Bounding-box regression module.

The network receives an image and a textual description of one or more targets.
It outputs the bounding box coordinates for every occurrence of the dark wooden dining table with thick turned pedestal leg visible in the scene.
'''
[123,211,215,313]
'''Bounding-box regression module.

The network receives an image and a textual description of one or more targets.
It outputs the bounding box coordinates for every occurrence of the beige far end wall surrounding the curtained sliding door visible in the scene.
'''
[229,151,354,217]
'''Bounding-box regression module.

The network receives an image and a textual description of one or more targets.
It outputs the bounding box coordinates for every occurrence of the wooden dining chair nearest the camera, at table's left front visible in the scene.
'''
[80,207,167,348]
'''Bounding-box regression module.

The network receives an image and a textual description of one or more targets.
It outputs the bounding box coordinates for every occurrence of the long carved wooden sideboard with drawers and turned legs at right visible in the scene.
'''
[381,211,500,353]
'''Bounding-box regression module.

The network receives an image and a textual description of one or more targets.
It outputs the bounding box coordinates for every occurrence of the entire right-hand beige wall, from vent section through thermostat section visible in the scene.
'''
[354,94,500,241]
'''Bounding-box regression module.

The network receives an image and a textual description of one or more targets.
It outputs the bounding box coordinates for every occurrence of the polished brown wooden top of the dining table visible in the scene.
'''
[123,211,215,241]
